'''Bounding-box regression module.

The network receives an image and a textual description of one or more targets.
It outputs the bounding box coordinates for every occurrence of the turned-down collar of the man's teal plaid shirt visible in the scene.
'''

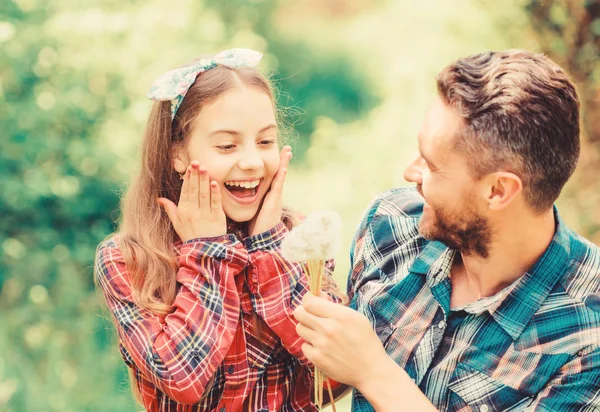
[410,207,572,340]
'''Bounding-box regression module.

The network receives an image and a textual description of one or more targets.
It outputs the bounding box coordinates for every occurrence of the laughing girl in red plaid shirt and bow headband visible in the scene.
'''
[95,49,344,412]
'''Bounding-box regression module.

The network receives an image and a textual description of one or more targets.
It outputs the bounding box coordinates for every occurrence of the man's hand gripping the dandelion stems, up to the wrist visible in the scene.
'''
[294,293,391,388]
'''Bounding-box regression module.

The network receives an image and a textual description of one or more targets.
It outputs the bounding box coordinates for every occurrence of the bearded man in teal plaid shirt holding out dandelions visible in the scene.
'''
[295,50,600,411]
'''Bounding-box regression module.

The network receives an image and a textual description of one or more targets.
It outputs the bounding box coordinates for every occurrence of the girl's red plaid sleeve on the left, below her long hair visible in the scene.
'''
[94,235,248,404]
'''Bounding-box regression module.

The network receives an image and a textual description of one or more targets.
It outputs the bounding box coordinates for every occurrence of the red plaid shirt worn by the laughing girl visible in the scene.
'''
[95,223,328,412]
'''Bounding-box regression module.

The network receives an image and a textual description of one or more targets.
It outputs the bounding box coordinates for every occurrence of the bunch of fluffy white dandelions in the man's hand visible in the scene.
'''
[281,211,341,412]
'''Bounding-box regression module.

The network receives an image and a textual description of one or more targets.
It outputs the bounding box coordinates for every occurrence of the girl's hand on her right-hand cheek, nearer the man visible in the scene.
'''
[249,146,292,235]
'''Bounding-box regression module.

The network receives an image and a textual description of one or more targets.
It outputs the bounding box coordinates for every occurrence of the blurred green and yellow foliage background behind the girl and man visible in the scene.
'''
[0,0,600,411]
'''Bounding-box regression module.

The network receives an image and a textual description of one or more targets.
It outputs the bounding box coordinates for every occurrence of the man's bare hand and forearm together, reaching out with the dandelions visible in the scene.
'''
[294,294,436,411]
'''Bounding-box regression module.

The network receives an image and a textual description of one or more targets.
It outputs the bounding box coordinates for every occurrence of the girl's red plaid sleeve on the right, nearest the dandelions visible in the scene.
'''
[244,222,339,365]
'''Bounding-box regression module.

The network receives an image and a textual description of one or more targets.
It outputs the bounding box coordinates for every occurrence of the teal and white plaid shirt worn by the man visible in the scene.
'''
[348,189,600,412]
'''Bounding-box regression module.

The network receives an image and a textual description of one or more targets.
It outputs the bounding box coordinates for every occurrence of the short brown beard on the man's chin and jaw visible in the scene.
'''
[419,200,492,258]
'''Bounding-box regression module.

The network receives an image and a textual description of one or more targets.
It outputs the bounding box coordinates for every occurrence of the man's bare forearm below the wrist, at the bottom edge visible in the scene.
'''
[356,356,437,412]
